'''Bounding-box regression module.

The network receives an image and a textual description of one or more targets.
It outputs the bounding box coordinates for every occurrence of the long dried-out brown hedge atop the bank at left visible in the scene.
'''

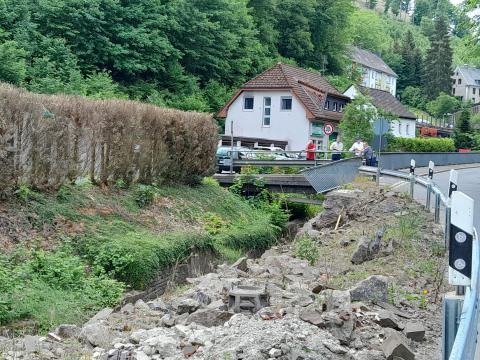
[0,84,218,190]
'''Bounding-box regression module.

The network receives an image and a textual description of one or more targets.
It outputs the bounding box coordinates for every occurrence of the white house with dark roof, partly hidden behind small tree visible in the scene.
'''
[344,85,417,138]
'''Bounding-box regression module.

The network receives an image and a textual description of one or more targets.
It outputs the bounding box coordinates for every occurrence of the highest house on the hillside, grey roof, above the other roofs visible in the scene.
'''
[351,46,398,96]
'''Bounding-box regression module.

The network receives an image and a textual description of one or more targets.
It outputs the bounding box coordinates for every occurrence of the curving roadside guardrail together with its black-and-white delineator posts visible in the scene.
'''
[360,160,480,360]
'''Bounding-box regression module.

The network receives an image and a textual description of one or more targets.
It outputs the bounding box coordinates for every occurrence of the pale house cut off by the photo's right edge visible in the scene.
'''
[452,65,480,104]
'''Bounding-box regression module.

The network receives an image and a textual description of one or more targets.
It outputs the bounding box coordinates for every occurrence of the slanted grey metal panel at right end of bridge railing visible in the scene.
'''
[300,157,362,193]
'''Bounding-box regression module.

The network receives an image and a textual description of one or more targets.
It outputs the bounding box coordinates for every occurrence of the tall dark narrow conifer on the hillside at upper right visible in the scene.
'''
[423,17,453,99]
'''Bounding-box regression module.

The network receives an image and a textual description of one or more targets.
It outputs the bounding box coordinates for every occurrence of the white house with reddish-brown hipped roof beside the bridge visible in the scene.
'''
[218,63,350,150]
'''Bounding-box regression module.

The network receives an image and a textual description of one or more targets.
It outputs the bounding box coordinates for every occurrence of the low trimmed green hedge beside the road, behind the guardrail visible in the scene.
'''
[387,138,455,152]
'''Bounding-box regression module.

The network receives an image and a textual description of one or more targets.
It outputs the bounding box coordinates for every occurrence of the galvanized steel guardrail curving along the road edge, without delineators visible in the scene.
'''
[360,166,480,360]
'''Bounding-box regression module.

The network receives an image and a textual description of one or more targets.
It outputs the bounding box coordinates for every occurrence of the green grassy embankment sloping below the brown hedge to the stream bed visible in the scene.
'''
[0,181,284,332]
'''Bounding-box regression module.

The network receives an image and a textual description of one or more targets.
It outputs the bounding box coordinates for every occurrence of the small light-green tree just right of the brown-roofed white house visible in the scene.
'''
[340,96,378,147]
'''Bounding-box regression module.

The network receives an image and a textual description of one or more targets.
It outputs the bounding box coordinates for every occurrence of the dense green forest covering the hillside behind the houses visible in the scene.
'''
[0,0,479,112]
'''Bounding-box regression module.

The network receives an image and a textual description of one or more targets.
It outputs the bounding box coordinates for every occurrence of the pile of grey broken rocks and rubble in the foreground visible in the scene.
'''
[0,184,440,360]
